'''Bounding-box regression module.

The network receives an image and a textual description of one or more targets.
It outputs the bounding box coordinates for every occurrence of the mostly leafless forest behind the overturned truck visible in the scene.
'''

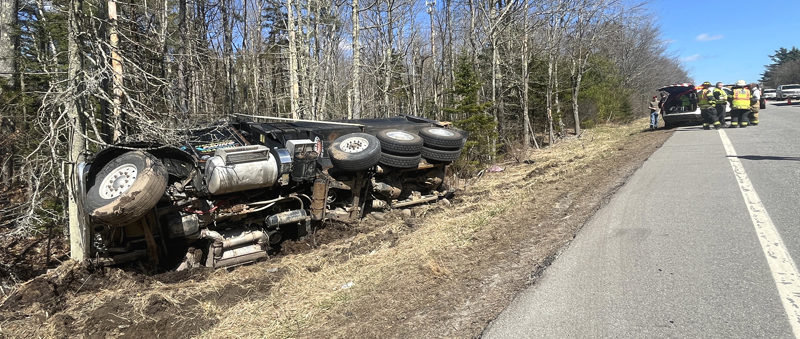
[0,0,688,258]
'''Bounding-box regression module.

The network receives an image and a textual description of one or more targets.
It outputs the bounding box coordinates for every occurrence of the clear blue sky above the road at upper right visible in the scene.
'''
[646,0,800,84]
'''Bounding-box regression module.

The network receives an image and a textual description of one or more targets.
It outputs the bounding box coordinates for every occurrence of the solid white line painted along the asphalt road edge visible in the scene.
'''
[719,130,800,338]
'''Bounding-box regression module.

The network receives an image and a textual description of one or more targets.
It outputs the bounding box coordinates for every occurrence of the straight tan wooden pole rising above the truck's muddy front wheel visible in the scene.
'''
[108,0,122,143]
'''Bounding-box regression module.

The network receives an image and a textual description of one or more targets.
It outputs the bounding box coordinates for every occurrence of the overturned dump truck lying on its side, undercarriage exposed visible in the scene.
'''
[79,116,465,270]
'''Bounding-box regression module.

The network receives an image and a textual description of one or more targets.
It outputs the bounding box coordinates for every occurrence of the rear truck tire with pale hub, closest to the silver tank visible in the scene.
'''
[328,133,381,172]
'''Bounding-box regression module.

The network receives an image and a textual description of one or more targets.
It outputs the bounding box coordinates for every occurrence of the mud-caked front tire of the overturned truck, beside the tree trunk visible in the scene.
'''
[85,151,168,226]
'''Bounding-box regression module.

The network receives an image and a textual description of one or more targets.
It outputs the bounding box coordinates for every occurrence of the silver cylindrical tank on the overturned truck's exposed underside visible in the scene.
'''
[205,145,278,194]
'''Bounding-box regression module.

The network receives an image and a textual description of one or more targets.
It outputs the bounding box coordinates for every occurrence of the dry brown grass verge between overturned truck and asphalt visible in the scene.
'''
[0,120,668,338]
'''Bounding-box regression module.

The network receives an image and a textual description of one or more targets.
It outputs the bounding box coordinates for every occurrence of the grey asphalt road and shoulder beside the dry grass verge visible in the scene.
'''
[484,104,800,338]
